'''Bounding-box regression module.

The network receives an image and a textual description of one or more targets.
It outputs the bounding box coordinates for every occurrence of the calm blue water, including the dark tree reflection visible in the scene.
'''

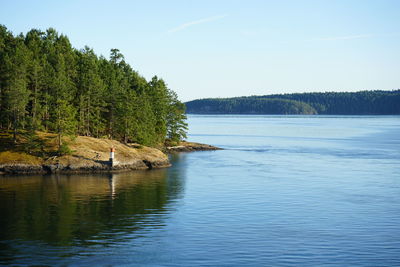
[0,115,400,266]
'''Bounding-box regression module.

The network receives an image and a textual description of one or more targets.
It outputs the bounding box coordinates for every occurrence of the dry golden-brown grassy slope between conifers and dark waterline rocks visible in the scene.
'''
[0,132,167,166]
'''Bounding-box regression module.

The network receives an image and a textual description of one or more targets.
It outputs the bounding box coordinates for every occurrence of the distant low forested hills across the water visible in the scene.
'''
[185,90,400,115]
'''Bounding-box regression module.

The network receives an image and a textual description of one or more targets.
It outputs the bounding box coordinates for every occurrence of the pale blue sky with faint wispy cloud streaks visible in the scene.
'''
[0,0,400,101]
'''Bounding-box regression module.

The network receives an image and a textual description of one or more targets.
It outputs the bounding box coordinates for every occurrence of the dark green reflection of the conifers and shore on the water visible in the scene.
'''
[0,156,187,263]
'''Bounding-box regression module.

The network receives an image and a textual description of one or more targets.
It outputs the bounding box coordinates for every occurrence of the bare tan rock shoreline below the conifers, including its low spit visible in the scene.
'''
[0,136,220,175]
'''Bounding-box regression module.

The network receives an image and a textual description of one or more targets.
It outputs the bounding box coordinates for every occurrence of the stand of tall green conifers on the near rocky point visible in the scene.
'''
[0,25,187,151]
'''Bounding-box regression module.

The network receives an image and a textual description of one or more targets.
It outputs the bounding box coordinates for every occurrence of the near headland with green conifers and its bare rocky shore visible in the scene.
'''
[0,25,222,176]
